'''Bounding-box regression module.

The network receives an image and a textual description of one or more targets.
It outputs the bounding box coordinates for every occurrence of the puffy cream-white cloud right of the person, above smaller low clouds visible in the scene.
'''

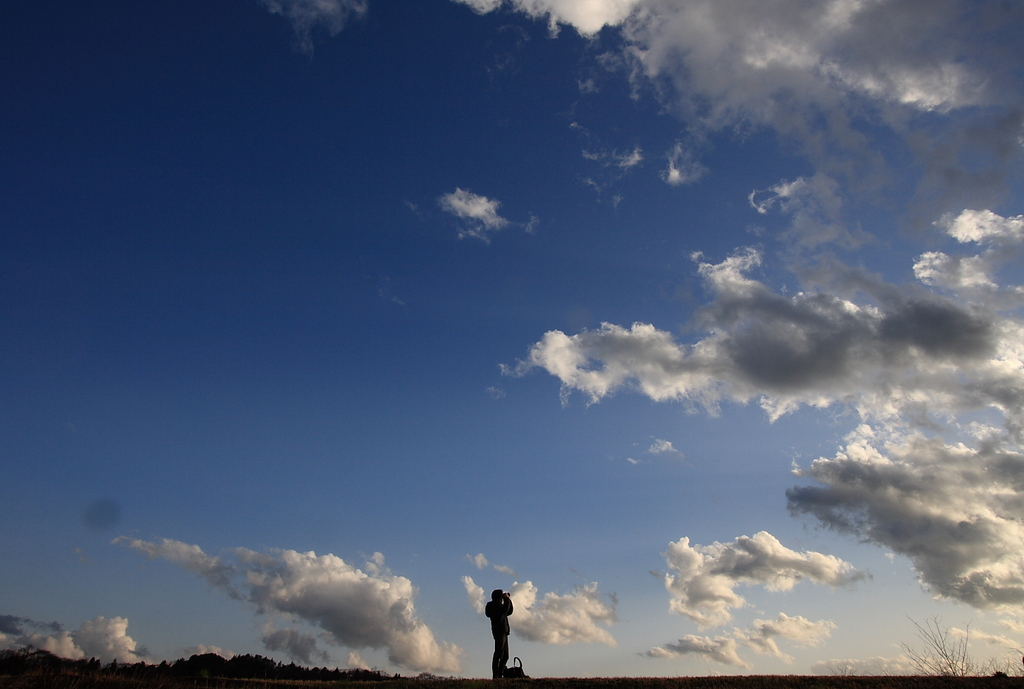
[664,531,863,629]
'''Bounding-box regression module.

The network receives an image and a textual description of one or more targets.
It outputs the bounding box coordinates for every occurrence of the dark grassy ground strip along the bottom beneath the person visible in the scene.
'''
[0,673,1024,689]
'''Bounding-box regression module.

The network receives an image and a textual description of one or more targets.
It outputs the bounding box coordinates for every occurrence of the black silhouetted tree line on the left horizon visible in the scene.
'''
[0,646,397,682]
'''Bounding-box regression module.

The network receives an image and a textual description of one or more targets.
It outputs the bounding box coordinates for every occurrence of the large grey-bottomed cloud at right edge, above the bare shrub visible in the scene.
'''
[786,426,1024,609]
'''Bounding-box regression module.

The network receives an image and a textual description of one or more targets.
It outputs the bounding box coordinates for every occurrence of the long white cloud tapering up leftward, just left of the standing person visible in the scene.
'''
[115,536,462,672]
